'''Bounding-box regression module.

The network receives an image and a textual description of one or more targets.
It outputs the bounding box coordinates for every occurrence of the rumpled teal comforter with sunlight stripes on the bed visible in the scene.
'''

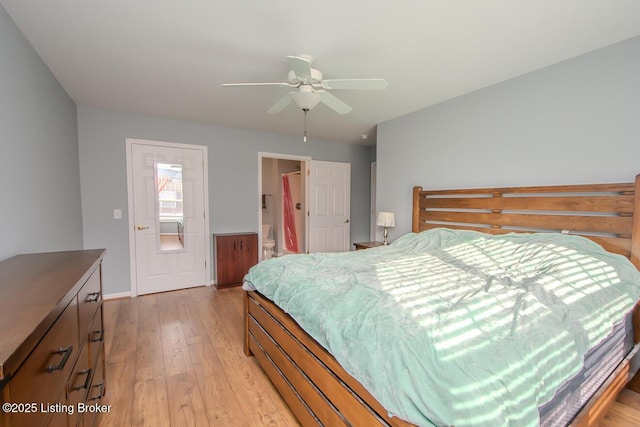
[245,229,640,427]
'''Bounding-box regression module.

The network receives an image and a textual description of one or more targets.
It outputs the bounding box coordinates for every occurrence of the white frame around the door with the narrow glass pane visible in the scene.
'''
[125,138,212,297]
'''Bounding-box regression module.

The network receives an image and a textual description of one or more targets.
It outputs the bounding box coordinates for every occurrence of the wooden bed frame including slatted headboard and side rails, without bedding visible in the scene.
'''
[244,175,640,426]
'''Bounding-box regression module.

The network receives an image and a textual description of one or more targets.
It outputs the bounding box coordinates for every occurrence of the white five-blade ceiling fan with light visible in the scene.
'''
[221,55,387,114]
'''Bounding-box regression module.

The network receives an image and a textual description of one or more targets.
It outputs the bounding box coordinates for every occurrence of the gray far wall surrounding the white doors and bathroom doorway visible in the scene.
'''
[78,106,373,294]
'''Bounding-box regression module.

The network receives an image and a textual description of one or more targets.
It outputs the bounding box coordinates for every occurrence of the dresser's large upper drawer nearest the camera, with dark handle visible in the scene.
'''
[10,298,79,426]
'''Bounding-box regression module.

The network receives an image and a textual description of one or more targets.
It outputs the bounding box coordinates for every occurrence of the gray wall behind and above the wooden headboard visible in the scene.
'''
[376,37,640,239]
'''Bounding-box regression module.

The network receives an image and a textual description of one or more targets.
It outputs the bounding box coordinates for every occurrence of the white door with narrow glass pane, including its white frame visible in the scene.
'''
[127,140,208,295]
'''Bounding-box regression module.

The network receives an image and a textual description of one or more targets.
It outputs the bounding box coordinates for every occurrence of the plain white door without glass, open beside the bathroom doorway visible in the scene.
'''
[309,160,351,253]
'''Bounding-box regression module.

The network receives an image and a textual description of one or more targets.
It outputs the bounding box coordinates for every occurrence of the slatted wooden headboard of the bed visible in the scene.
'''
[412,175,640,270]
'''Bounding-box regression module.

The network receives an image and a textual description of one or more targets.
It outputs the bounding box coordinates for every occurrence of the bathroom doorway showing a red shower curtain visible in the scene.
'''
[259,153,311,259]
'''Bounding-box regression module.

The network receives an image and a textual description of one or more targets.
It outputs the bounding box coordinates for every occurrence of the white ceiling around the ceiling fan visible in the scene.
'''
[0,0,640,144]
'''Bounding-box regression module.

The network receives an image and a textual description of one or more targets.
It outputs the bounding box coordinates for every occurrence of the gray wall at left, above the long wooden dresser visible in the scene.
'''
[0,6,82,260]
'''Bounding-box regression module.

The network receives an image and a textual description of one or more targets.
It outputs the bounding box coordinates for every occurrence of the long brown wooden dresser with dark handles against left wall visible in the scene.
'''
[0,249,109,427]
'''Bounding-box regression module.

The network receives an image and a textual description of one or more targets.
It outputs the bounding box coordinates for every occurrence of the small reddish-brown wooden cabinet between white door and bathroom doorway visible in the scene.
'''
[213,233,258,289]
